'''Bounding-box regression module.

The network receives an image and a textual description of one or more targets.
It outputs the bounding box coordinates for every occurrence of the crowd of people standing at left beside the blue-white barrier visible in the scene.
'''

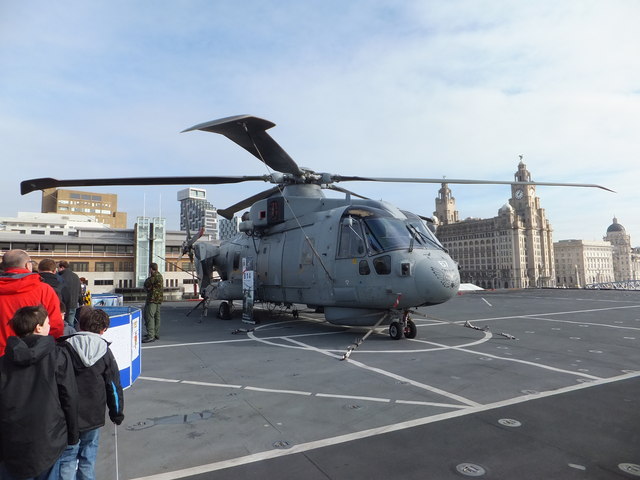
[0,250,124,480]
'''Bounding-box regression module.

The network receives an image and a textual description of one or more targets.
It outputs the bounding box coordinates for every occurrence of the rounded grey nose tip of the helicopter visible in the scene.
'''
[415,259,460,305]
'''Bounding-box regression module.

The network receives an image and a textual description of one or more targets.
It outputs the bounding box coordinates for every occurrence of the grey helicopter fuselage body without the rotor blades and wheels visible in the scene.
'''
[195,185,460,326]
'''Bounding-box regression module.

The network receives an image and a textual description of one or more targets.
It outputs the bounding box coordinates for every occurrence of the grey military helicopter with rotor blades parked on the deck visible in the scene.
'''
[21,115,609,340]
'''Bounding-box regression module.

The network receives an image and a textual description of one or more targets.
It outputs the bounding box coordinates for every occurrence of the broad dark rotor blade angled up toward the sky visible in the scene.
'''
[183,115,302,175]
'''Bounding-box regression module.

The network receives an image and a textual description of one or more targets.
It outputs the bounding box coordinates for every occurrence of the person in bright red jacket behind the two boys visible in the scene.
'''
[0,250,64,356]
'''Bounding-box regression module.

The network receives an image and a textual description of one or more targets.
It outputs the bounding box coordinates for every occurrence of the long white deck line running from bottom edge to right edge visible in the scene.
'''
[131,372,640,480]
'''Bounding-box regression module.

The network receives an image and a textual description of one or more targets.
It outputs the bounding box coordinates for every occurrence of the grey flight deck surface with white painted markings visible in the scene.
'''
[97,289,640,480]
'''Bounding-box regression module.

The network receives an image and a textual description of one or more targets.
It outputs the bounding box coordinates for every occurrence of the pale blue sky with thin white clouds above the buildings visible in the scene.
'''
[0,0,640,246]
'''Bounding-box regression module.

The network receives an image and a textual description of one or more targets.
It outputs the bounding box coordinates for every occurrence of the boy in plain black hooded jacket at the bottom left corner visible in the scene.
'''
[0,305,78,480]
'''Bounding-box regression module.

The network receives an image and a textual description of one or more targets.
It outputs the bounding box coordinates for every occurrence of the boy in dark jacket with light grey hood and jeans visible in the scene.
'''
[60,305,124,480]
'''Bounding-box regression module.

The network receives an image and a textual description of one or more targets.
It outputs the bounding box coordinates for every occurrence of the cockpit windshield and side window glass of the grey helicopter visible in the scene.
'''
[340,207,444,256]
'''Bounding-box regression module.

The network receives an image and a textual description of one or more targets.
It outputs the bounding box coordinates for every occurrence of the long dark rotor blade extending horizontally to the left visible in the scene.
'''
[20,175,270,195]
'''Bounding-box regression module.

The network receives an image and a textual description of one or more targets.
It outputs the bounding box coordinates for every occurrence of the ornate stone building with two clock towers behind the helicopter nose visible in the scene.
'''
[434,161,556,288]
